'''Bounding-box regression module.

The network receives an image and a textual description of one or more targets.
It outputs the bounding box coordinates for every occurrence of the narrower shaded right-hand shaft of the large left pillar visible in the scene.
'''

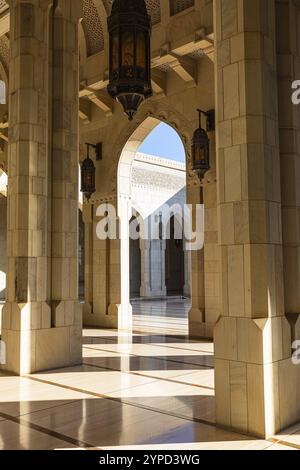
[50,0,80,338]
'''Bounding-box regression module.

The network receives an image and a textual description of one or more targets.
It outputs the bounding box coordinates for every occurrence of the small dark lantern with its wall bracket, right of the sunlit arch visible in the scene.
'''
[192,109,215,179]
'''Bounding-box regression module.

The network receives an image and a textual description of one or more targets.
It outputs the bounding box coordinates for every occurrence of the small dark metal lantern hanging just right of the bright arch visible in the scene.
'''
[192,109,211,179]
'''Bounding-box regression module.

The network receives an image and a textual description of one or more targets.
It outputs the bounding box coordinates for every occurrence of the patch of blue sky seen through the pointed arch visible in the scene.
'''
[139,123,185,162]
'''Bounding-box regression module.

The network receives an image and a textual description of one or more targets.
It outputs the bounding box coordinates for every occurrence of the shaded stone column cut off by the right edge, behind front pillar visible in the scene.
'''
[276,0,300,427]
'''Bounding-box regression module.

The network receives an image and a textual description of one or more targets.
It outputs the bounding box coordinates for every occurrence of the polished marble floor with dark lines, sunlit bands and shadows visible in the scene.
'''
[0,299,300,450]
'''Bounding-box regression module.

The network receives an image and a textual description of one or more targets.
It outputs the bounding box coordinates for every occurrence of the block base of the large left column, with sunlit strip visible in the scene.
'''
[1,302,82,375]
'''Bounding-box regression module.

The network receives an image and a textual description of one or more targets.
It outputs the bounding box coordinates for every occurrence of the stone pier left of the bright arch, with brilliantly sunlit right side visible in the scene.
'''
[83,195,132,331]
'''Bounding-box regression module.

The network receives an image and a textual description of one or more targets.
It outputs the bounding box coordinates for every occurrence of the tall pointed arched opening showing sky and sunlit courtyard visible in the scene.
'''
[118,117,190,334]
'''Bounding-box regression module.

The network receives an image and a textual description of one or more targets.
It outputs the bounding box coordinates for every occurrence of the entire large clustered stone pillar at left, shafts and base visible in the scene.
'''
[2,0,81,374]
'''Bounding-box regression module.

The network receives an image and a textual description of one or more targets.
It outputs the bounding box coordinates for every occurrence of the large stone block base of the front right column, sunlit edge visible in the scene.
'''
[214,317,300,439]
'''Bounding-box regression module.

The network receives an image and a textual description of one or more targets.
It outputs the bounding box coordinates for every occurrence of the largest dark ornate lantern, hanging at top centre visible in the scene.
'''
[108,0,152,120]
